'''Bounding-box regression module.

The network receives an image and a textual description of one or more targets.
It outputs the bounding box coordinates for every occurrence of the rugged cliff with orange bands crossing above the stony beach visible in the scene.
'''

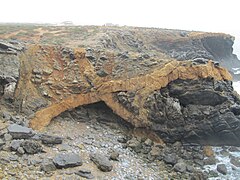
[0,27,240,146]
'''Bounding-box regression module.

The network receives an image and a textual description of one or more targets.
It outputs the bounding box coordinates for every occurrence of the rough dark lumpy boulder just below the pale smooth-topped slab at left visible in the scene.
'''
[21,140,43,154]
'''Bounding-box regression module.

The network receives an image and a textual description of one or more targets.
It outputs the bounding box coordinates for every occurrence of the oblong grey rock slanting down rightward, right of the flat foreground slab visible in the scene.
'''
[90,153,113,172]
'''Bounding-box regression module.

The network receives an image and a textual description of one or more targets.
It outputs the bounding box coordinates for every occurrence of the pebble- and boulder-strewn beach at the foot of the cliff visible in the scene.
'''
[0,107,240,180]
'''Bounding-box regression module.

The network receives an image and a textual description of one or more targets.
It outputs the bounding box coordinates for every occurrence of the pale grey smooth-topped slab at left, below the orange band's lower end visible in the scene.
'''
[8,124,34,139]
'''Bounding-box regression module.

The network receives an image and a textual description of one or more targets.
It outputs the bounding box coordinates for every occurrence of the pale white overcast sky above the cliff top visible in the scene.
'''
[0,0,240,54]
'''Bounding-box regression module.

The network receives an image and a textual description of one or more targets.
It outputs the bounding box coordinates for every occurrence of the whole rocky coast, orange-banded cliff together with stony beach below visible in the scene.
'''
[0,27,240,180]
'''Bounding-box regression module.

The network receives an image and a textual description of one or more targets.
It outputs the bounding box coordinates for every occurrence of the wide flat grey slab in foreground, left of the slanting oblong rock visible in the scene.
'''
[53,153,82,168]
